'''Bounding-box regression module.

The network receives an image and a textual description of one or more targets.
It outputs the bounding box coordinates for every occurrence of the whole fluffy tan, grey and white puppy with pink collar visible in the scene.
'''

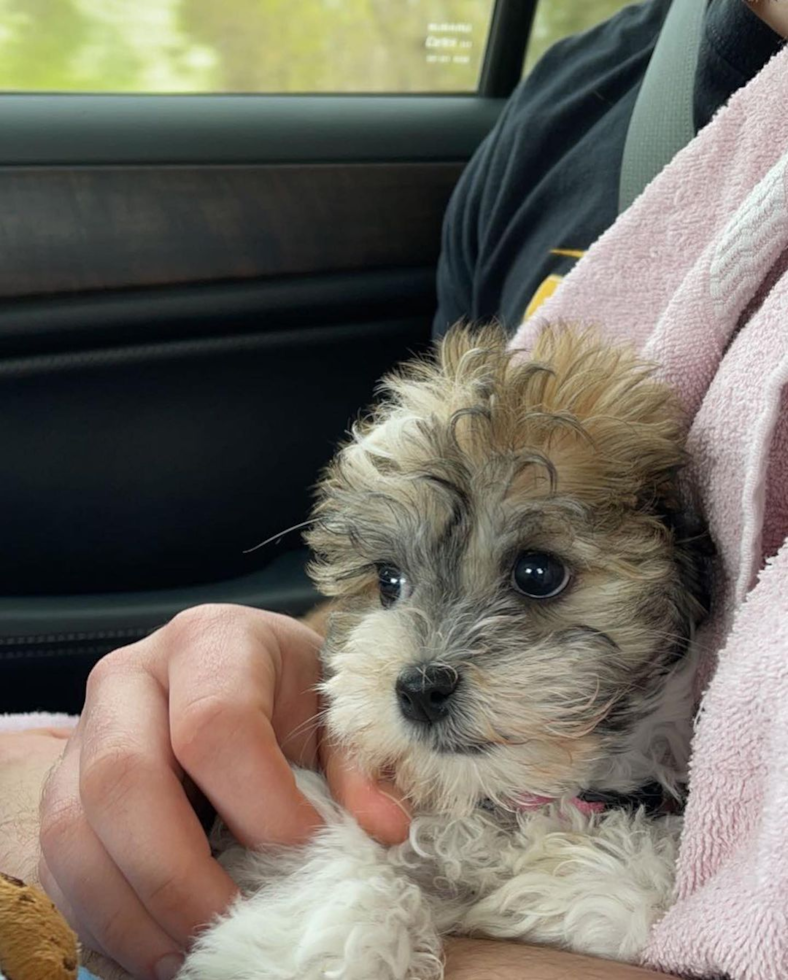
[180,328,708,980]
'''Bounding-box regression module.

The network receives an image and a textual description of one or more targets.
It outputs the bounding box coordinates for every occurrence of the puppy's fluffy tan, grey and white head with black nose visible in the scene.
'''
[308,329,701,813]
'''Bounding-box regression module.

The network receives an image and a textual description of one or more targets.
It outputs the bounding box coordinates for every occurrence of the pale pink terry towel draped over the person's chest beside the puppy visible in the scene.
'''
[513,40,788,980]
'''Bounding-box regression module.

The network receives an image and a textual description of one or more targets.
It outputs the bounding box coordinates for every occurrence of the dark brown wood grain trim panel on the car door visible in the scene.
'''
[0,163,462,298]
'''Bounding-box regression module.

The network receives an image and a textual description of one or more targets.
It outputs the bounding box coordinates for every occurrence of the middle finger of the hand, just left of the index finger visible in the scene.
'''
[76,658,236,955]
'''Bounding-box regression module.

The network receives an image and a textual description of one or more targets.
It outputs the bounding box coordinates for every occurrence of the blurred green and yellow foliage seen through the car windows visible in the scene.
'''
[0,0,623,92]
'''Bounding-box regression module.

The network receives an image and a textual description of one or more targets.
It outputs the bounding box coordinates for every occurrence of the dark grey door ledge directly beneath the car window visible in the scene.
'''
[0,94,504,166]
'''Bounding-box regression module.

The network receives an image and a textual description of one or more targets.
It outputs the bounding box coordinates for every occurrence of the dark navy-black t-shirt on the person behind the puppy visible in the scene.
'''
[434,0,784,336]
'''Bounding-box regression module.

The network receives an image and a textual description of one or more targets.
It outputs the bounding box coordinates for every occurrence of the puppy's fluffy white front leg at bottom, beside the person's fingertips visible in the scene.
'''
[179,776,442,980]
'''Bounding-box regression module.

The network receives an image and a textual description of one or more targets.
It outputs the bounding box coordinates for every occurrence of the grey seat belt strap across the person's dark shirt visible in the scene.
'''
[618,0,707,214]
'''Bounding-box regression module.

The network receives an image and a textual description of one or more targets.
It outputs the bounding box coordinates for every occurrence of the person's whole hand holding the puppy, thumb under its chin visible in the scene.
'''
[39,605,408,980]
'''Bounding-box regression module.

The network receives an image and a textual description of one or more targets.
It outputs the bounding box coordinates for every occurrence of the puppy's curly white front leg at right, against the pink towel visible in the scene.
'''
[457,808,681,962]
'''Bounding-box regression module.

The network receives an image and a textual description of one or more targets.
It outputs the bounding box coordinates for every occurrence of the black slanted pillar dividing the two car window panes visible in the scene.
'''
[479,0,539,99]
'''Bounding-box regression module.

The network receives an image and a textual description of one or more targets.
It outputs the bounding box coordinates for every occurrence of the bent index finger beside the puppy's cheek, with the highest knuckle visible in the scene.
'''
[166,606,322,847]
